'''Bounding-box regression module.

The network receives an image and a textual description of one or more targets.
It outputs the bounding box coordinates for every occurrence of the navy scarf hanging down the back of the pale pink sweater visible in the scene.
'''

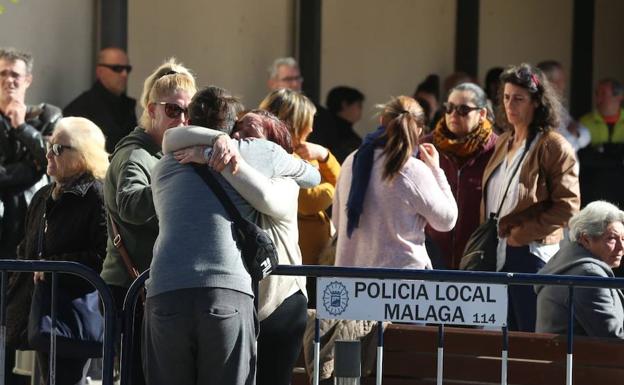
[347,127,386,238]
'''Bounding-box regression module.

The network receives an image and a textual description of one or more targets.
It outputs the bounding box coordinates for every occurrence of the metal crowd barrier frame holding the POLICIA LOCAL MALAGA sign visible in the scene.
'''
[121,265,624,385]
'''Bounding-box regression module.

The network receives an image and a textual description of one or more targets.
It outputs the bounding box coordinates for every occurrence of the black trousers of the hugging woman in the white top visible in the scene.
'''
[256,291,307,385]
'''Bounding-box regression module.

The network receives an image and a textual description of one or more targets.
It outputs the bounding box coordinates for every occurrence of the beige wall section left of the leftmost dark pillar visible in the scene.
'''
[0,0,96,107]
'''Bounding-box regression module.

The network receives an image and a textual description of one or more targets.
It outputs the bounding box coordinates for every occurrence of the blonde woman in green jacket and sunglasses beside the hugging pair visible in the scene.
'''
[101,59,196,385]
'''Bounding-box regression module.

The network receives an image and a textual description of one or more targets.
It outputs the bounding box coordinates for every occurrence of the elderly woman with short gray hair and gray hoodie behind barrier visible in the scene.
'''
[535,201,624,338]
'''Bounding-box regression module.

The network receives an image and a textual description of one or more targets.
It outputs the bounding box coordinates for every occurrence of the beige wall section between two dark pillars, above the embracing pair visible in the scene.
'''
[128,0,296,108]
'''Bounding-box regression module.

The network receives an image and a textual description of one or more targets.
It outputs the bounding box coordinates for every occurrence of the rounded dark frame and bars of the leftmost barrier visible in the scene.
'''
[0,259,117,385]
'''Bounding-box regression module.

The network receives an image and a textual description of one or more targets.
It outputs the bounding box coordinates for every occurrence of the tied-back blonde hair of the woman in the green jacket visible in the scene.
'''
[139,57,197,130]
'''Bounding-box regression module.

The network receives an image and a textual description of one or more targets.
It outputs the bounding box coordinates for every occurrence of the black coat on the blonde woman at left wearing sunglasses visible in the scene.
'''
[7,175,107,348]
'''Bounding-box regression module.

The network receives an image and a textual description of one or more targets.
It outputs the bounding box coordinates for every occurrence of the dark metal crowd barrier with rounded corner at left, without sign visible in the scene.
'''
[0,260,116,385]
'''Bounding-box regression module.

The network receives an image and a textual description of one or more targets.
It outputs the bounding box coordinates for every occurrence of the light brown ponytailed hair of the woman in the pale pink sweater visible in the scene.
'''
[377,96,425,180]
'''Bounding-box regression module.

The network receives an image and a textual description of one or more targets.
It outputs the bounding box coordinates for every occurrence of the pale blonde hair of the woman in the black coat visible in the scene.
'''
[54,117,109,180]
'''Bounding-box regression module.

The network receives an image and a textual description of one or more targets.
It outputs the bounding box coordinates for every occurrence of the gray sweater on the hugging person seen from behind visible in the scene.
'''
[146,140,318,297]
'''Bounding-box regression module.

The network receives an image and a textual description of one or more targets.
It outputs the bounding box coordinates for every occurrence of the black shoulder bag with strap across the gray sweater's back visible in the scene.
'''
[193,165,278,281]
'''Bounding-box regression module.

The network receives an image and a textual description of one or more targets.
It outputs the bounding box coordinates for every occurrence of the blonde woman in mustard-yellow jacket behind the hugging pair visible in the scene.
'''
[260,89,340,266]
